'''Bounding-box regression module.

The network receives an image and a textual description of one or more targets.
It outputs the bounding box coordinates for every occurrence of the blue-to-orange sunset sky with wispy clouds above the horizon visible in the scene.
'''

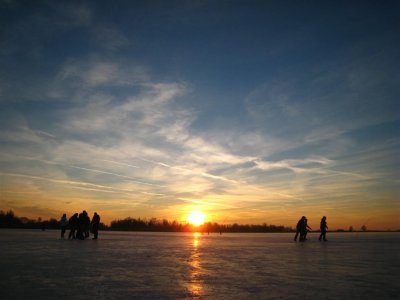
[0,0,400,230]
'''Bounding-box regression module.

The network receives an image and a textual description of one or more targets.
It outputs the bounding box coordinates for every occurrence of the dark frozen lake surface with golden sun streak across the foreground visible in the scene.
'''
[0,229,400,300]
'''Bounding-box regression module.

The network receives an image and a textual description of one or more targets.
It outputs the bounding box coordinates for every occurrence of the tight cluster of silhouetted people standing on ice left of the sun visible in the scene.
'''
[60,210,100,240]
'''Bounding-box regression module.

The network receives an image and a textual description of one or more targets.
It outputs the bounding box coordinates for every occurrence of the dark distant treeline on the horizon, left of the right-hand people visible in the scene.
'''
[0,210,293,232]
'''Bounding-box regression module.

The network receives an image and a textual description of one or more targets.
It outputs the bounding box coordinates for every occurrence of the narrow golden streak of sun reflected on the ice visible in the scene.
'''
[188,232,203,297]
